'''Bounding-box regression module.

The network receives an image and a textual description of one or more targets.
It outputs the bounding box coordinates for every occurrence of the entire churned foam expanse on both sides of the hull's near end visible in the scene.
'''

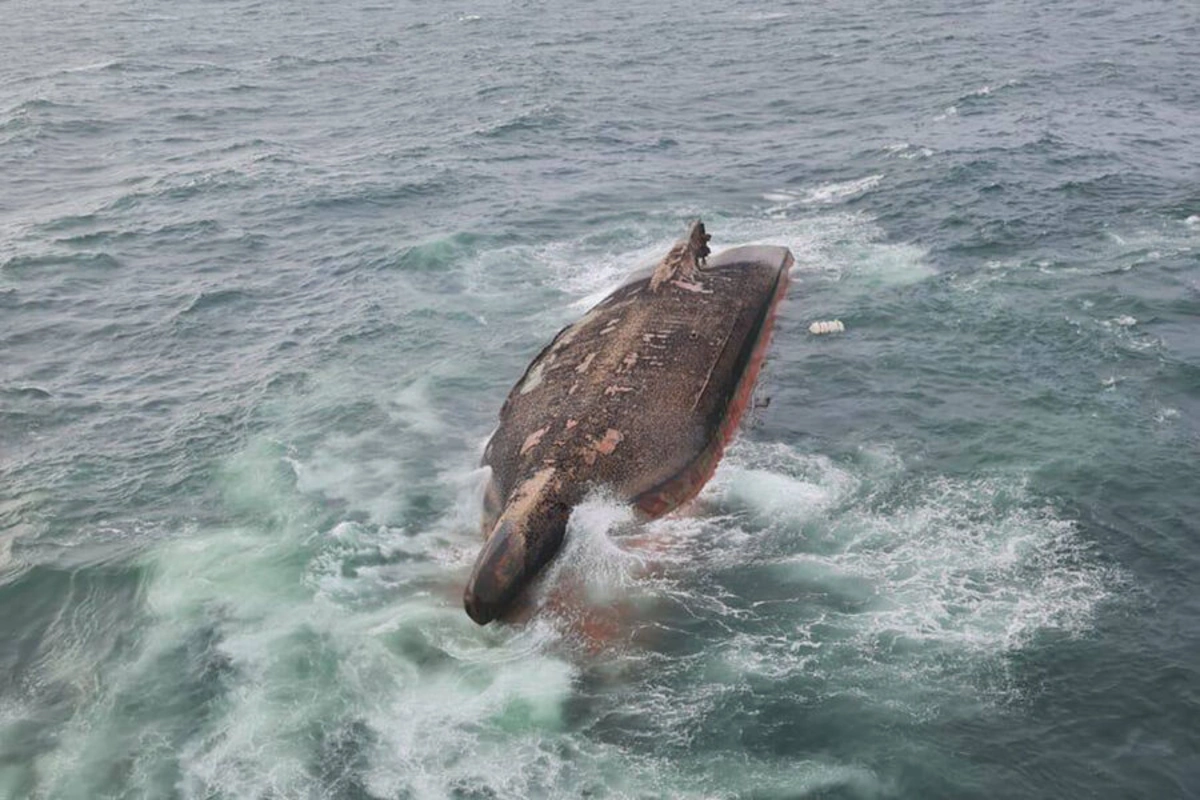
[18,422,1112,798]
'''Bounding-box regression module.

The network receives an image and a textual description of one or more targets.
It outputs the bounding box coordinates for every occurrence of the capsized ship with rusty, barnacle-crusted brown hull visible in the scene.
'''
[463,222,793,625]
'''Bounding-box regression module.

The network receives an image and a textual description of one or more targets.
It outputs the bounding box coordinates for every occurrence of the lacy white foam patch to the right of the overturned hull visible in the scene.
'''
[549,441,1124,728]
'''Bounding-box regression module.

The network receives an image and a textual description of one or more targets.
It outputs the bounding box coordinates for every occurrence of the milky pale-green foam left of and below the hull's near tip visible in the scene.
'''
[131,443,588,798]
